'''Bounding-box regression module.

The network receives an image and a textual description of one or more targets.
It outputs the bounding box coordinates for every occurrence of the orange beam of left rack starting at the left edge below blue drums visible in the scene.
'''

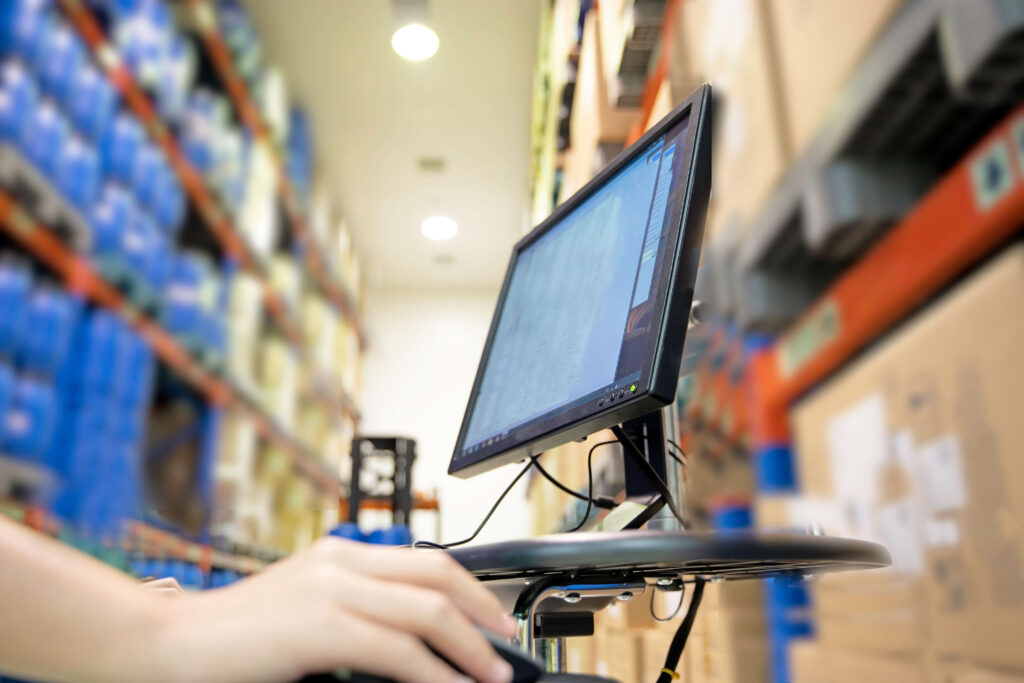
[0,191,339,494]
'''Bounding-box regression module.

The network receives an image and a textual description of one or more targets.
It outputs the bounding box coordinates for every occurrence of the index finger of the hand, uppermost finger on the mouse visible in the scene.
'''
[317,539,516,638]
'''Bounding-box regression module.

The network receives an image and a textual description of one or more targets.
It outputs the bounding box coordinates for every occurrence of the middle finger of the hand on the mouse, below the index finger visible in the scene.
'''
[336,577,512,683]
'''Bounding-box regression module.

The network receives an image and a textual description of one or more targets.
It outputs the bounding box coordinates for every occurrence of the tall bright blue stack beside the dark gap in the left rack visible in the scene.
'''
[51,310,156,539]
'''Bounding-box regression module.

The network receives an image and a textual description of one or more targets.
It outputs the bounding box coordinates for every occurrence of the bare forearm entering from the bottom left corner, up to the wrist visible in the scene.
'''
[0,518,169,682]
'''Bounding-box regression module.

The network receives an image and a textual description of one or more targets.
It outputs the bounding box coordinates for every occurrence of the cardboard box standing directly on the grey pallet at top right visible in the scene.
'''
[770,0,903,156]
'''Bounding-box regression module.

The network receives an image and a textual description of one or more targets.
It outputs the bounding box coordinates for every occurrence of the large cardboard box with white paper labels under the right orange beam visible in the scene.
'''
[794,246,1024,669]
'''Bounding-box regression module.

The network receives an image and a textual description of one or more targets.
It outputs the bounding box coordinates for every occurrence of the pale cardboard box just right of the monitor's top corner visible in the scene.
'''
[679,0,792,229]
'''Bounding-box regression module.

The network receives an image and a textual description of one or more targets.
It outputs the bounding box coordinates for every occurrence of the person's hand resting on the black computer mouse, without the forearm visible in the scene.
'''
[151,538,515,683]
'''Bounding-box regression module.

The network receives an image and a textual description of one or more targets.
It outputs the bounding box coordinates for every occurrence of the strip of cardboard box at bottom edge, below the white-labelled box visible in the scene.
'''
[790,640,927,683]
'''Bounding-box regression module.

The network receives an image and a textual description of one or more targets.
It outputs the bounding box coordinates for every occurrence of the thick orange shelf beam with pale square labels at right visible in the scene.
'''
[759,108,1024,413]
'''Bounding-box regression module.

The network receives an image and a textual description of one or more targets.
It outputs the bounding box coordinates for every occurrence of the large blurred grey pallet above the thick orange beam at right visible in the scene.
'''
[727,0,1024,331]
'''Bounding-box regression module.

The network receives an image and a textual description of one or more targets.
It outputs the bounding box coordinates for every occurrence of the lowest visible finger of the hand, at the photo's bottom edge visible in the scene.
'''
[319,618,469,683]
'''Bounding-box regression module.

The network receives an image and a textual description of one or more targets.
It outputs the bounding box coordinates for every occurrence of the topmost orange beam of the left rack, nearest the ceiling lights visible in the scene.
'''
[188,0,366,346]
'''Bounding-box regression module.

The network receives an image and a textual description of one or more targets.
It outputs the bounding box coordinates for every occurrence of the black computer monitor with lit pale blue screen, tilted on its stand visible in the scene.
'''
[449,85,711,477]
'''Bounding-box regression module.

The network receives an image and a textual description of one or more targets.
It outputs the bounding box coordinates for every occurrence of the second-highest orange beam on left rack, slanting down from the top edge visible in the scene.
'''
[59,0,305,358]
